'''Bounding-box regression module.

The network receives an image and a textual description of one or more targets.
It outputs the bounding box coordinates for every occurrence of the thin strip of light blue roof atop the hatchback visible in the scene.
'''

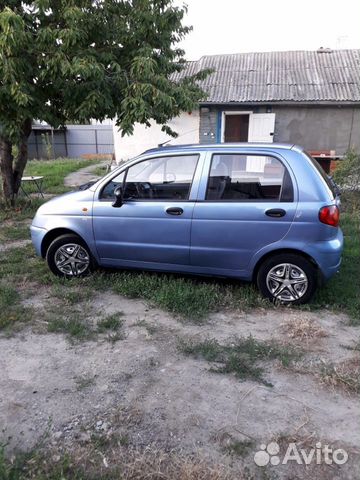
[143,142,303,154]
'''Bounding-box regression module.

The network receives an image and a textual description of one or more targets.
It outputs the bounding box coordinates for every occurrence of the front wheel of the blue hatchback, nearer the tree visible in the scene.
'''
[46,234,94,278]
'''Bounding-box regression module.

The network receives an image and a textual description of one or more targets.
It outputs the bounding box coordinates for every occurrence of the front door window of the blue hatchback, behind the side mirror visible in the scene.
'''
[100,155,199,200]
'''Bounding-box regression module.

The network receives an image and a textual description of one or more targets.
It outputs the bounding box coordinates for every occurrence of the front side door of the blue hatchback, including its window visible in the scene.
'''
[93,153,200,268]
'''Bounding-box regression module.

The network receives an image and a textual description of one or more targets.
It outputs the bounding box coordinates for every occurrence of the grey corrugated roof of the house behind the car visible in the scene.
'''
[174,49,360,103]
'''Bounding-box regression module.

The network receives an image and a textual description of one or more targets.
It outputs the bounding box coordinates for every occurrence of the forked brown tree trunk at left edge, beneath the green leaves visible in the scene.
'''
[0,118,32,206]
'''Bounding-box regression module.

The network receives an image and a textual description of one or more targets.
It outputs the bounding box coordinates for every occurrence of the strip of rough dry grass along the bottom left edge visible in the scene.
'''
[0,442,232,480]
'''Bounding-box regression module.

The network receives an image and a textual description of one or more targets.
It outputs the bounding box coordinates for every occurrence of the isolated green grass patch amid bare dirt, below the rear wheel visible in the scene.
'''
[178,336,301,386]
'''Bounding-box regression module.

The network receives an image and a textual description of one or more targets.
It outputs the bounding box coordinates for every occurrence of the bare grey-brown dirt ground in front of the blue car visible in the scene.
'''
[0,288,360,479]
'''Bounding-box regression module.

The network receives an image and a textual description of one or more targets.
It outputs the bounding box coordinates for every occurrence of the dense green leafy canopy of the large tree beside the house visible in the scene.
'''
[0,0,207,202]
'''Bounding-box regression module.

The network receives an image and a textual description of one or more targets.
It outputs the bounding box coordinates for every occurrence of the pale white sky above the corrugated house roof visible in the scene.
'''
[176,0,360,60]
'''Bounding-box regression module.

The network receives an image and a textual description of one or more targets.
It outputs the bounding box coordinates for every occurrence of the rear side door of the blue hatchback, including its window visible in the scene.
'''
[190,151,297,277]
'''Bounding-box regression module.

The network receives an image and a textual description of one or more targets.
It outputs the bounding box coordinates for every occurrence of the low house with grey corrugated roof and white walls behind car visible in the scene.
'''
[114,48,360,162]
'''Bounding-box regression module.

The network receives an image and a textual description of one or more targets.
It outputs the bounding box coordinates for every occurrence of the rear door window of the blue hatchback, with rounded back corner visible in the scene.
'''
[206,154,293,202]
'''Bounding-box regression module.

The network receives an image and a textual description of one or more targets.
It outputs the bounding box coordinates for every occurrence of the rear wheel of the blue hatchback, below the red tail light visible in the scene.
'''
[256,253,317,305]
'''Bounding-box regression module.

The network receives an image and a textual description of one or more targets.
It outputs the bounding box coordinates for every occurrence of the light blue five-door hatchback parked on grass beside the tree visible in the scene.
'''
[31,143,343,304]
